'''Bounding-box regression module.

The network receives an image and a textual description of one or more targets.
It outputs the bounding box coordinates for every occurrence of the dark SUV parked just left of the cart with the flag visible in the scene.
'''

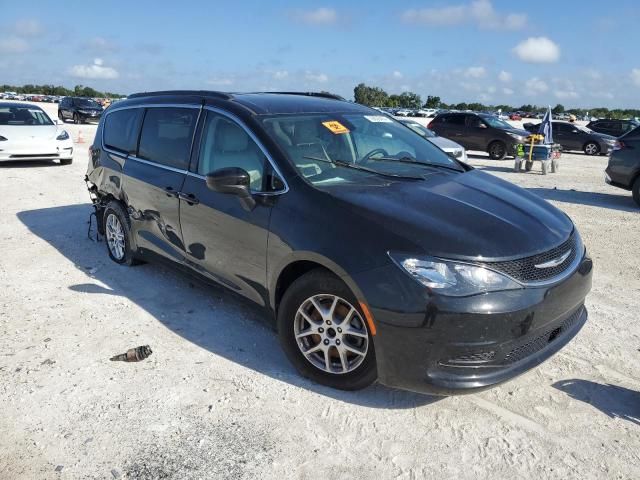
[429,113,529,160]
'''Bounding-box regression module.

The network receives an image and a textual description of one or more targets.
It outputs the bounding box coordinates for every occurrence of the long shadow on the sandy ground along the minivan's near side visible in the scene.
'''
[17,204,441,409]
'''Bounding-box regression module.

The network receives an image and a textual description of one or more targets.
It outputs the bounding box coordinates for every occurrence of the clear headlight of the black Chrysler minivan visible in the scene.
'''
[389,253,522,297]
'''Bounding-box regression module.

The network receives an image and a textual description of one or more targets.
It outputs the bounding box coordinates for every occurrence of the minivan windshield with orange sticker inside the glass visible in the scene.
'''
[263,113,464,184]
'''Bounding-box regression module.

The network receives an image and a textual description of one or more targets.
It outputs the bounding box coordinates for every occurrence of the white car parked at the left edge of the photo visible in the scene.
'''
[0,101,73,165]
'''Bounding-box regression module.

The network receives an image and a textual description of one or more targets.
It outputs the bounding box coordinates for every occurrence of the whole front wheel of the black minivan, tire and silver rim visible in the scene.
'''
[277,269,378,390]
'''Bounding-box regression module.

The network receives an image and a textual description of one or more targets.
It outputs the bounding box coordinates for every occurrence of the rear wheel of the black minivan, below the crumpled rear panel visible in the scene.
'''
[102,200,141,266]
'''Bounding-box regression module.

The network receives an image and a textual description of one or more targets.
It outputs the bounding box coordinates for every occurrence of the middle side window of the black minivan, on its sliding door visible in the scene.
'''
[138,107,198,170]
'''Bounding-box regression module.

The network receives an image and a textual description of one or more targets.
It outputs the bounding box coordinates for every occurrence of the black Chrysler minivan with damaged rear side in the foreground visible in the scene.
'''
[87,91,592,394]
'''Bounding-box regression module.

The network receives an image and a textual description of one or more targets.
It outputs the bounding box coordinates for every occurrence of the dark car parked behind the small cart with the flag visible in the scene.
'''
[523,120,616,155]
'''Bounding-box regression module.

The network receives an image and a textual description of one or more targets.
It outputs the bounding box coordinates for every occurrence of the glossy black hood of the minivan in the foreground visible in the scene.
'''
[324,170,573,261]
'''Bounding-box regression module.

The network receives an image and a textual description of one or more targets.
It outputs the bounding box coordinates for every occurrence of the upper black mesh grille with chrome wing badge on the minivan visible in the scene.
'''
[484,234,582,283]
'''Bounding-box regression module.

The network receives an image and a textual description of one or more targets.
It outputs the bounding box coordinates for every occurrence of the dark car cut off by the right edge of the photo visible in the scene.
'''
[605,127,640,206]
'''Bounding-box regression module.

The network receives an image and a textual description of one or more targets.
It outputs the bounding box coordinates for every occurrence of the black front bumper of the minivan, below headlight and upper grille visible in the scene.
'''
[354,251,593,395]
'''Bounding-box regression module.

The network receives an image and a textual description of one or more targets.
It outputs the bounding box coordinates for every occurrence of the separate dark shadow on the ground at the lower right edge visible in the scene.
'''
[553,379,640,425]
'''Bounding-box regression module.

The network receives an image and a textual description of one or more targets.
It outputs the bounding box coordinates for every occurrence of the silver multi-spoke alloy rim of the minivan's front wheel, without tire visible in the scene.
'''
[293,294,369,375]
